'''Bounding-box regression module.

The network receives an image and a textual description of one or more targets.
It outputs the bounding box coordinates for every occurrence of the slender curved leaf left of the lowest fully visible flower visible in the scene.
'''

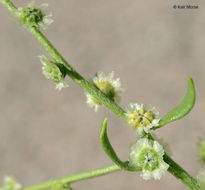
[100,118,141,171]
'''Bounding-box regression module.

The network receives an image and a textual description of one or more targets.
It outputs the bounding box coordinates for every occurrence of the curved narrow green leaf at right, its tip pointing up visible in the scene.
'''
[153,78,195,129]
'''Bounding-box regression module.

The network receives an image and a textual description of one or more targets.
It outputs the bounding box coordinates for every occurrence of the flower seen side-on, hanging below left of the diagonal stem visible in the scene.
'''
[39,55,68,90]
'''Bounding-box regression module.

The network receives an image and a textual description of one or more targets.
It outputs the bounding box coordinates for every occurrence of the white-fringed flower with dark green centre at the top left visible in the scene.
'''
[15,1,53,29]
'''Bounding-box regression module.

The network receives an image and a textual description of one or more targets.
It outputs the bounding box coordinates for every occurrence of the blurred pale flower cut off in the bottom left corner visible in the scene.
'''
[0,176,22,190]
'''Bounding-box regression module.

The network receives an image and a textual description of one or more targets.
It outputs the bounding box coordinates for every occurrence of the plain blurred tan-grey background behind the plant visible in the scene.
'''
[0,0,205,190]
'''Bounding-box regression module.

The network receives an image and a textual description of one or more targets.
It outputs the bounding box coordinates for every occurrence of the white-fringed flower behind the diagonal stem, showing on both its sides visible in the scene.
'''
[85,72,123,112]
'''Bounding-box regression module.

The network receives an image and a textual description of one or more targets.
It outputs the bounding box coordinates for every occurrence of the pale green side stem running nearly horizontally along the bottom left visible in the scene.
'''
[22,165,122,190]
